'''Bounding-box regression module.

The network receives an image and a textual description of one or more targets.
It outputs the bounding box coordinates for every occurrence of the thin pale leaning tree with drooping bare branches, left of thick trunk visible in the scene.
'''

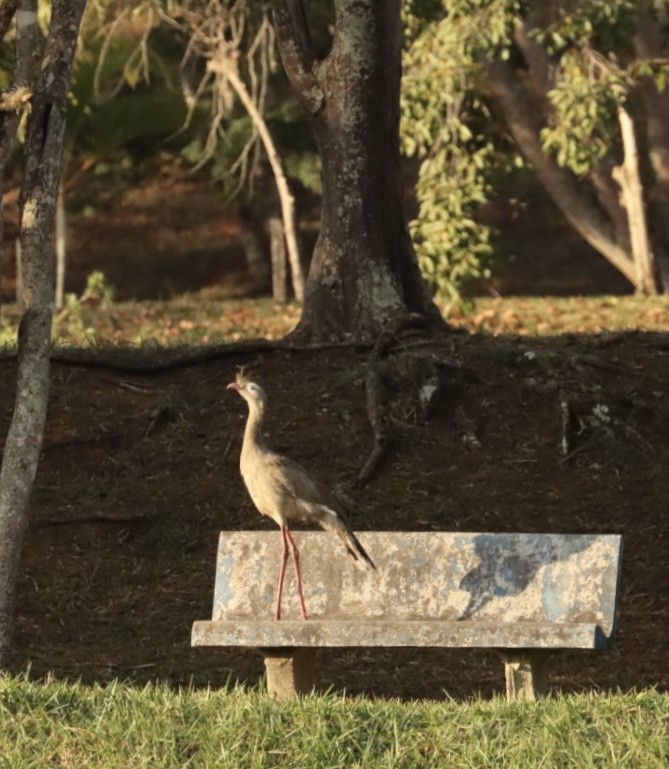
[82,0,312,300]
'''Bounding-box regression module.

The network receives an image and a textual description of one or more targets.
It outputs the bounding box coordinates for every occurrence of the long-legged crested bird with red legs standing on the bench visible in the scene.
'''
[226,370,376,620]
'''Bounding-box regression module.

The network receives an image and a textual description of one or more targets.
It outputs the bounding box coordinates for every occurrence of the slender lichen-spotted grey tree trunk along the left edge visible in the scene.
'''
[0,0,86,667]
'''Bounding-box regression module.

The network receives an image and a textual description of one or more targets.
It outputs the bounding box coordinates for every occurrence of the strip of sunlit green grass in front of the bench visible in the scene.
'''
[0,677,669,769]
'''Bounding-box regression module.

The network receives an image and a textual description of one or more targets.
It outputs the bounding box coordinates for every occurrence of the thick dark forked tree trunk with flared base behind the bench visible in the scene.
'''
[272,0,445,342]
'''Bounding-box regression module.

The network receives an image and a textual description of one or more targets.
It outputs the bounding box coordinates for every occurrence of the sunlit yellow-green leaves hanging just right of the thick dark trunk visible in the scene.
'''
[402,0,518,304]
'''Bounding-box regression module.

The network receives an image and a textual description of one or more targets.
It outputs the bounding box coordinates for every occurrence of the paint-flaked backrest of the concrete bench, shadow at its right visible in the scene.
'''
[212,530,621,646]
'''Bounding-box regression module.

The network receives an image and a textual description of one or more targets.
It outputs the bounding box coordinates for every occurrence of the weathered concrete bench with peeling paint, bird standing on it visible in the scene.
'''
[192,531,622,699]
